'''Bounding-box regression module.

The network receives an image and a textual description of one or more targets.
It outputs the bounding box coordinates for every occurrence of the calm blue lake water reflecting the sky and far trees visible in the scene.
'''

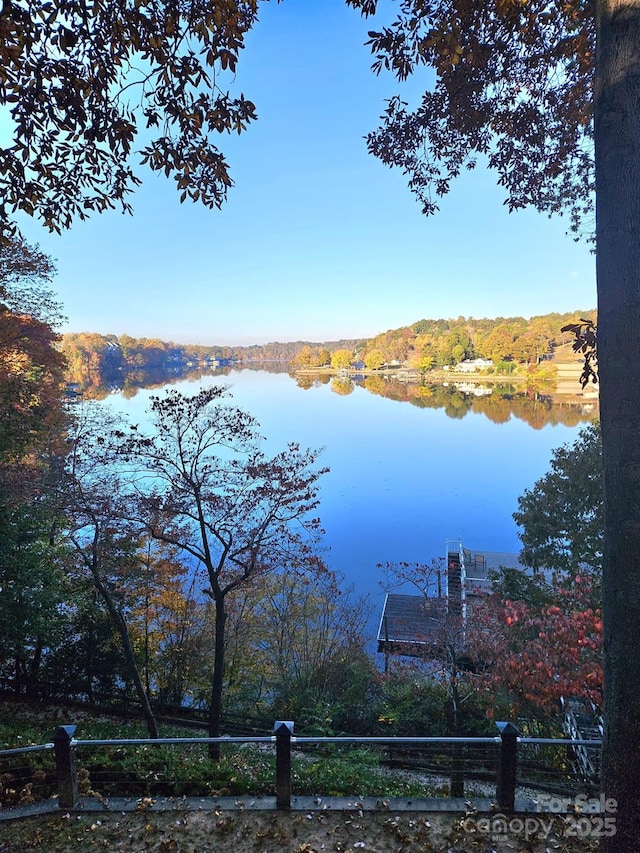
[100,370,591,611]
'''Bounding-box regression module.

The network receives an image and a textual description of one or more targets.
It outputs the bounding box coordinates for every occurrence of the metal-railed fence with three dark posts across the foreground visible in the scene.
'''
[0,721,602,814]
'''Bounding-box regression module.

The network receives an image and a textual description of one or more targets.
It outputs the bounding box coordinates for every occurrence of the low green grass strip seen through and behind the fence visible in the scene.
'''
[0,703,442,806]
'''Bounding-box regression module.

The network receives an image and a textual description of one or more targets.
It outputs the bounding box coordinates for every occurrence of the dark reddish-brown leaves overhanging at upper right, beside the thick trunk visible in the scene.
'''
[347,0,595,232]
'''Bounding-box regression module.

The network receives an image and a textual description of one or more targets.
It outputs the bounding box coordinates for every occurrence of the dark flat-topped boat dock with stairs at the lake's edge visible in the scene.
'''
[377,540,530,657]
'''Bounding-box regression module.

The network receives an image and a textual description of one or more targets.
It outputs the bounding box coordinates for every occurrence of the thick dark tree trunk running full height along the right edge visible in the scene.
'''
[595,0,640,853]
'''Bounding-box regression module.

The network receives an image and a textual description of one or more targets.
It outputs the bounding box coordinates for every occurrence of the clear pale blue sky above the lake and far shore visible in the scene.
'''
[6,0,596,345]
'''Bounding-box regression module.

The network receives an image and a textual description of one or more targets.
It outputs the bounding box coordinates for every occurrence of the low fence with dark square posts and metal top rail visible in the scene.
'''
[0,720,602,812]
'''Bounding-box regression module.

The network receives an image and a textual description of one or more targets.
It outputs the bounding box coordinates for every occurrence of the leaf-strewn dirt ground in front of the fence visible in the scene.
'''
[0,803,602,853]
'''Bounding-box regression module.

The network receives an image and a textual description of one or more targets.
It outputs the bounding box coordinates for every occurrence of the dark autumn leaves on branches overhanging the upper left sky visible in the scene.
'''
[0,0,268,236]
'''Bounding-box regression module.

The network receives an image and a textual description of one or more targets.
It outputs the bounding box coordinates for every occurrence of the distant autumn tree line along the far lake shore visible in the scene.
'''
[59,310,595,396]
